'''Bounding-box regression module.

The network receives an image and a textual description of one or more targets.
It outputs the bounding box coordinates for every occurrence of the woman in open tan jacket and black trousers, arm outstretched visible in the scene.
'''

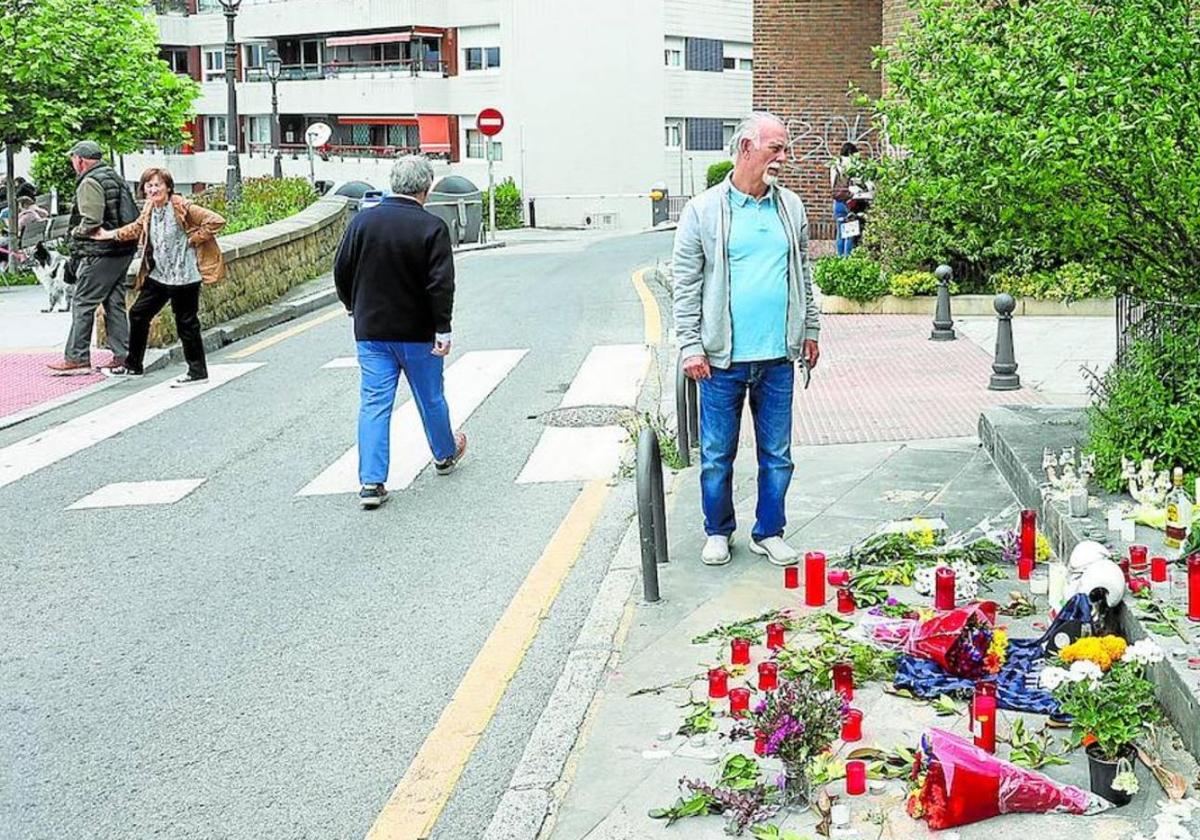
[96,167,226,388]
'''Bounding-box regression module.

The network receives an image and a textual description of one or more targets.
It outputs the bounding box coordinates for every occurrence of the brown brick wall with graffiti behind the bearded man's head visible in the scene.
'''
[754,0,888,239]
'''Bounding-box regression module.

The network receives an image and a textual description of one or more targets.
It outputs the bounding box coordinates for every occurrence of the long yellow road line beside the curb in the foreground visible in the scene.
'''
[367,481,608,840]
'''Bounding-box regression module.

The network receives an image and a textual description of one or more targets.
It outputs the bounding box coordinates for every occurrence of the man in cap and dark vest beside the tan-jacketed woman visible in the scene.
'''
[49,140,138,376]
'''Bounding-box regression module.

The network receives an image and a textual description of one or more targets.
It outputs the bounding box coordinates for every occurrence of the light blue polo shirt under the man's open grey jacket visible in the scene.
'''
[728,185,791,361]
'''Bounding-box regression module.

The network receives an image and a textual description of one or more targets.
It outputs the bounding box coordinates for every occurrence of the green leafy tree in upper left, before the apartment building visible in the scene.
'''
[0,0,199,226]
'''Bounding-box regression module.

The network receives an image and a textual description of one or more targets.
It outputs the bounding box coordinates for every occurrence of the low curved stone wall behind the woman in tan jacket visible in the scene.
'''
[115,198,350,347]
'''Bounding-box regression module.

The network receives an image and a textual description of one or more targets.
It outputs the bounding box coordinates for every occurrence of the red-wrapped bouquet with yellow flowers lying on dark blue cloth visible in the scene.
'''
[904,604,1008,679]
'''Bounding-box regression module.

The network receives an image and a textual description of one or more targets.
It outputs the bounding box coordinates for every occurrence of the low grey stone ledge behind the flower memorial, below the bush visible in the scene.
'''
[979,407,1200,758]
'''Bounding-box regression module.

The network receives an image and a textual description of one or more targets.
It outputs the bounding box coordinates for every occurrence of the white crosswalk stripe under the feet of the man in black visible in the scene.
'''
[296,350,529,496]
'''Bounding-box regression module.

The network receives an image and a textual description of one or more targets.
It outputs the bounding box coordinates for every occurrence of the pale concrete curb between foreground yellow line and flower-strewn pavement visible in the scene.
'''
[484,520,641,840]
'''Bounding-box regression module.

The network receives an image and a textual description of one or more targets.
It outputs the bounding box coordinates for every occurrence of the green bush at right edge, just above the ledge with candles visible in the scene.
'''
[1087,318,1200,492]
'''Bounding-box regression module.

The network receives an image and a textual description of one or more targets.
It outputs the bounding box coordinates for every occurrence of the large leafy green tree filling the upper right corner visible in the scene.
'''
[876,0,1200,300]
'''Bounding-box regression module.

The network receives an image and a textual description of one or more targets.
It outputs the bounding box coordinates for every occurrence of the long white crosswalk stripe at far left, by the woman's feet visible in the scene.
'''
[0,362,262,487]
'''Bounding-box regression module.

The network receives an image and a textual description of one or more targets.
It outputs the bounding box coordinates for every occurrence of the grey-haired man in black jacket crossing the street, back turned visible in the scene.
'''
[334,155,467,509]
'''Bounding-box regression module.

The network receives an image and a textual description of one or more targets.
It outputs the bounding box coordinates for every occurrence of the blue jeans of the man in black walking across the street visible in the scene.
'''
[356,341,455,484]
